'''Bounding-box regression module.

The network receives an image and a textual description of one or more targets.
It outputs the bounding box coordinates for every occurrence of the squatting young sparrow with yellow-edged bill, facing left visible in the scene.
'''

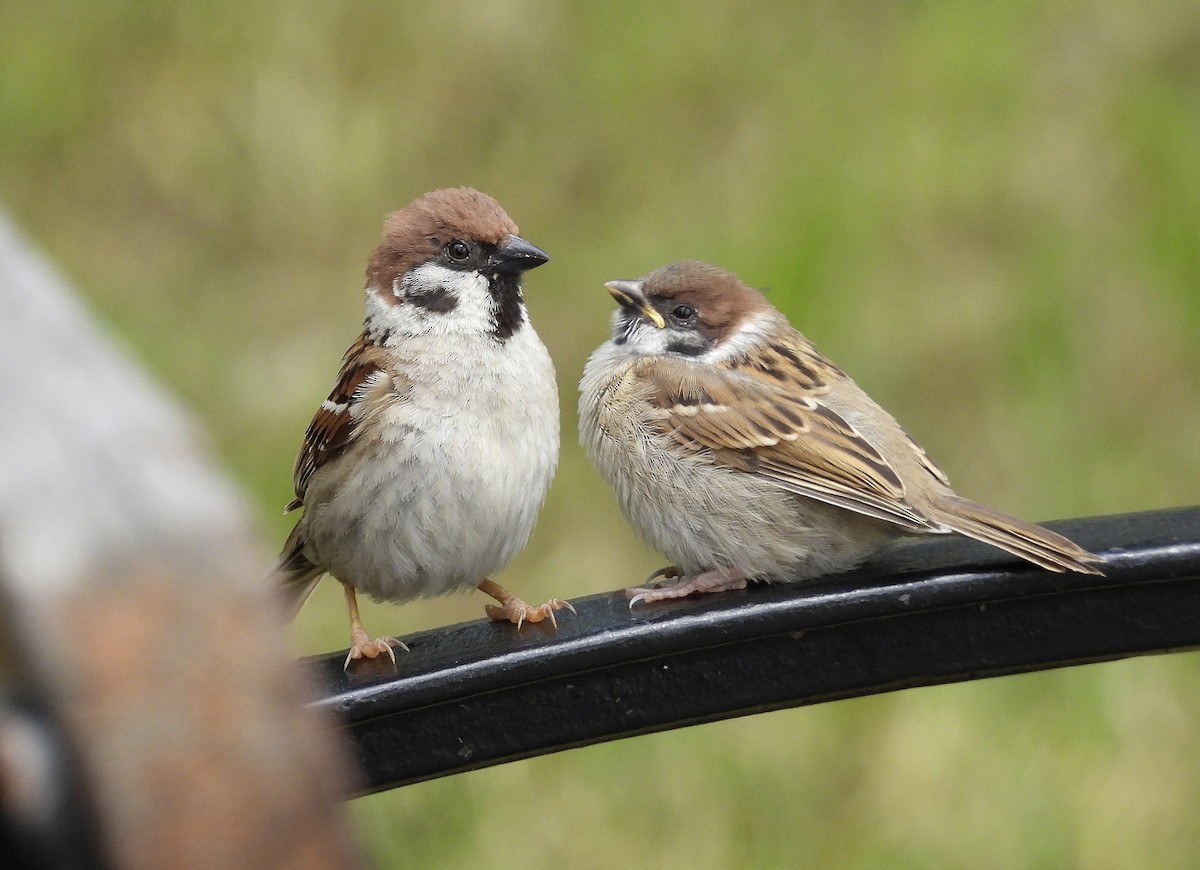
[580,260,1103,607]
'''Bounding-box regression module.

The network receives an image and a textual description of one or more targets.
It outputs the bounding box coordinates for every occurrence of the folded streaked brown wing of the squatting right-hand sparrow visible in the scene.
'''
[640,358,940,530]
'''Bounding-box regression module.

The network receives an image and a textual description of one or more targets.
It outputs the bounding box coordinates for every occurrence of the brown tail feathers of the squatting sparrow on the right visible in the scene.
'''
[937,496,1104,574]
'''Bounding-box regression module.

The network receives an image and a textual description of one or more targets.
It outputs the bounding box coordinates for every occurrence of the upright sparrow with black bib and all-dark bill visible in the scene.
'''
[275,187,574,667]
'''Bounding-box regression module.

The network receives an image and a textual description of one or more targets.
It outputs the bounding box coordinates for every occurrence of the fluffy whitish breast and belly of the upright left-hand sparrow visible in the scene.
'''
[305,323,559,601]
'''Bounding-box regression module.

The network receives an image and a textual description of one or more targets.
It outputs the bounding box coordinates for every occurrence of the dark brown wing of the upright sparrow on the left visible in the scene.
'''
[286,336,386,511]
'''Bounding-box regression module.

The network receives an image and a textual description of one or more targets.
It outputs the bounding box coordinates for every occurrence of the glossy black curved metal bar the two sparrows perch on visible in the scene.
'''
[314,508,1200,792]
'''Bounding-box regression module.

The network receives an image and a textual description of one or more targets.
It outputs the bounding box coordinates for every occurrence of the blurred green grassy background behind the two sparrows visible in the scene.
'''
[0,0,1200,868]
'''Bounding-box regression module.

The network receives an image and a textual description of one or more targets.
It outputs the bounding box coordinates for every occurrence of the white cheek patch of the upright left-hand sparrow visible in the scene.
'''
[367,263,496,338]
